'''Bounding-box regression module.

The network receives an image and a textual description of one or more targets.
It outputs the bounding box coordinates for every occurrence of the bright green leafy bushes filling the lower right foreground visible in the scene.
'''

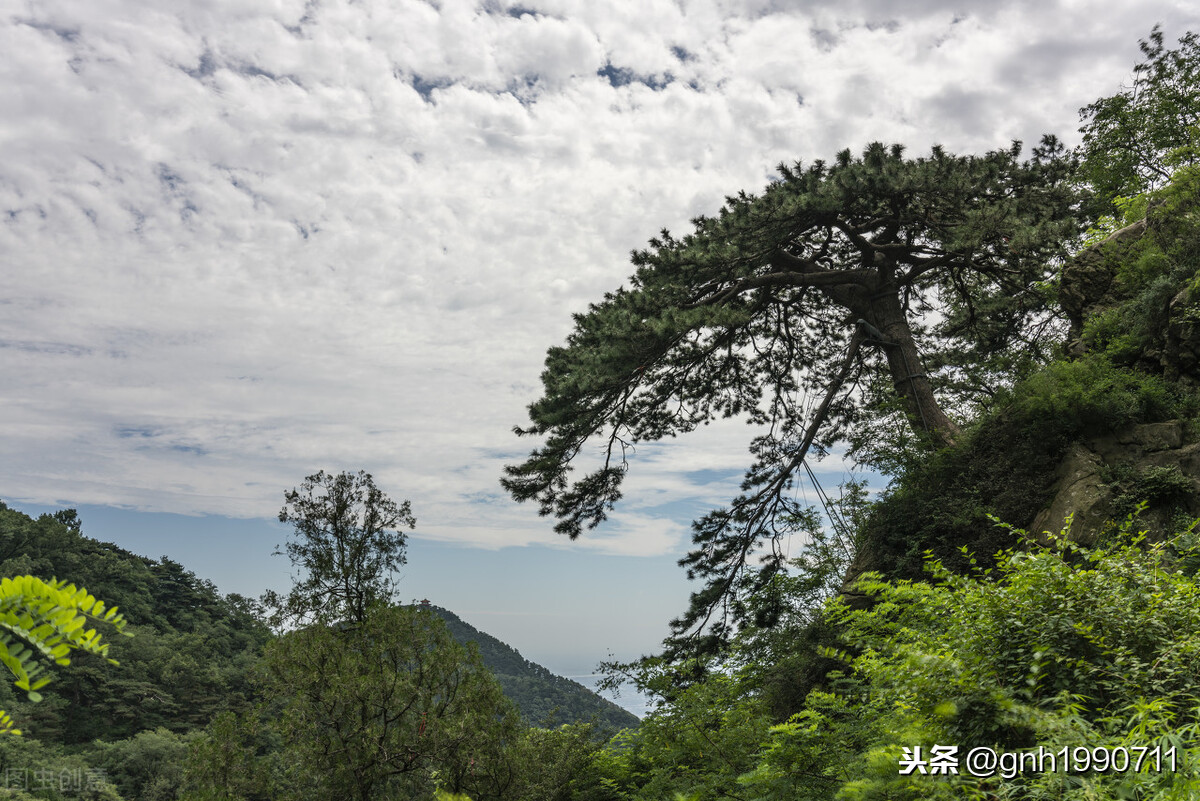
[583,515,1200,801]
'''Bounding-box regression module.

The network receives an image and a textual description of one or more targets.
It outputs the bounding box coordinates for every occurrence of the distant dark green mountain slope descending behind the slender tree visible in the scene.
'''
[428,604,638,729]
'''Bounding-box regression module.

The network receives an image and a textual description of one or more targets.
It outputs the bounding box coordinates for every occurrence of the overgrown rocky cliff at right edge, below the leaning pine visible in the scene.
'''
[846,165,1200,588]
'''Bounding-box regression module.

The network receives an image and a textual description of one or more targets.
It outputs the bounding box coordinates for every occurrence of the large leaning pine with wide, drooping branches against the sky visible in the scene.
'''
[503,137,1078,652]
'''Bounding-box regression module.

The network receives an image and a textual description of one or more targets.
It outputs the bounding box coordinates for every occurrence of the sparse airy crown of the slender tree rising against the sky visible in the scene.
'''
[264,470,416,624]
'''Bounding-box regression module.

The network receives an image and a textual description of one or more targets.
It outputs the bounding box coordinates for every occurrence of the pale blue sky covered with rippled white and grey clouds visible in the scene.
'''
[0,0,1198,714]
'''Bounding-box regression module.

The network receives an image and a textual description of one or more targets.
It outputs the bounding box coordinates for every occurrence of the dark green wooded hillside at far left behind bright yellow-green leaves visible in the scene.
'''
[0,505,270,745]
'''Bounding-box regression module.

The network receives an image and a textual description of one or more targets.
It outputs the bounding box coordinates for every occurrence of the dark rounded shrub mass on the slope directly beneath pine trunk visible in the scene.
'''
[857,354,1200,579]
